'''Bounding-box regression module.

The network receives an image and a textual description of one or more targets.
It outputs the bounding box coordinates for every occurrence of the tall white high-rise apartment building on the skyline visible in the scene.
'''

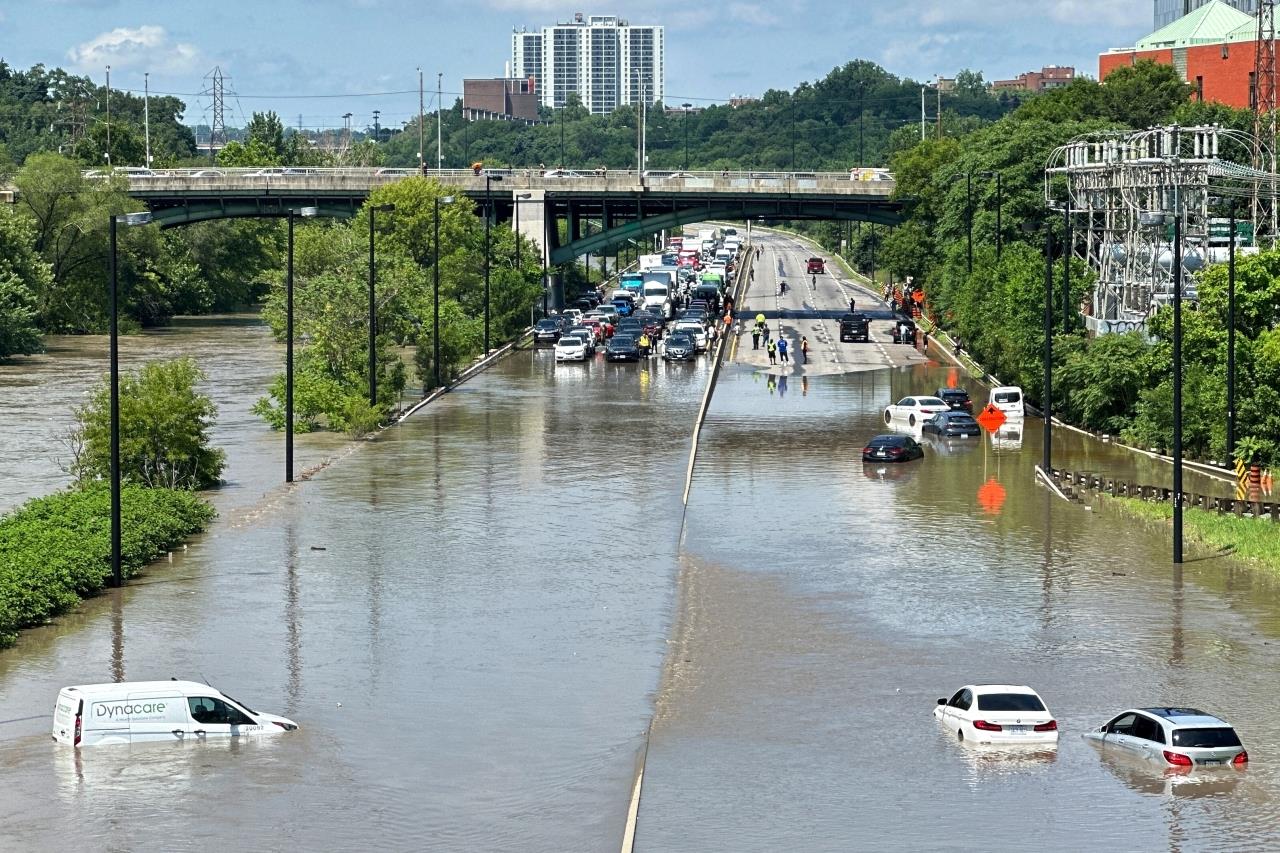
[511,14,663,114]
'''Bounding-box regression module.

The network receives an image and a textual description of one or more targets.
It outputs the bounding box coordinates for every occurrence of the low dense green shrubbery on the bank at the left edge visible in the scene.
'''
[0,483,215,648]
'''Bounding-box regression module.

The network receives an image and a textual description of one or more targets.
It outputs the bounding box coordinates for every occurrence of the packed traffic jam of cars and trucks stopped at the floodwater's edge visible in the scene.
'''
[532,228,742,364]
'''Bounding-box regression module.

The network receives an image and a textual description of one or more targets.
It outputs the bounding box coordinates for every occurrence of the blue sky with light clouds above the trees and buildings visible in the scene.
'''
[0,0,1153,128]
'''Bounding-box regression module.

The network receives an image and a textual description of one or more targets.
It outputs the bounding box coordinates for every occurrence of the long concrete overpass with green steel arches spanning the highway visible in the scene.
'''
[115,167,904,265]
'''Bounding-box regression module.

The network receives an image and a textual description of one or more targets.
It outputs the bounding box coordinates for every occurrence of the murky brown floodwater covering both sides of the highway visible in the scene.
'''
[0,238,1280,852]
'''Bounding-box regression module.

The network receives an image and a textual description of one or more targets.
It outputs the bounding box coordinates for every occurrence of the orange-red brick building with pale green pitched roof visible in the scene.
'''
[1098,0,1274,109]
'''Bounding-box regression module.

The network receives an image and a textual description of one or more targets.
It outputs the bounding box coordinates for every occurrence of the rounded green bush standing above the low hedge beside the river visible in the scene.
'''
[70,359,225,489]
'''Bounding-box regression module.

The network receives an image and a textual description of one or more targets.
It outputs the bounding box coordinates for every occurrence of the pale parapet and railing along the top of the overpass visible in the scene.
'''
[94,167,895,197]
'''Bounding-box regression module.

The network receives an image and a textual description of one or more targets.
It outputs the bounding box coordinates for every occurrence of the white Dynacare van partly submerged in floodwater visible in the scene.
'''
[52,681,298,747]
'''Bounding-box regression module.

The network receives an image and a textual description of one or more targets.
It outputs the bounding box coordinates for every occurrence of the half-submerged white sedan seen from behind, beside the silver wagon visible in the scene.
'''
[933,684,1057,744]
